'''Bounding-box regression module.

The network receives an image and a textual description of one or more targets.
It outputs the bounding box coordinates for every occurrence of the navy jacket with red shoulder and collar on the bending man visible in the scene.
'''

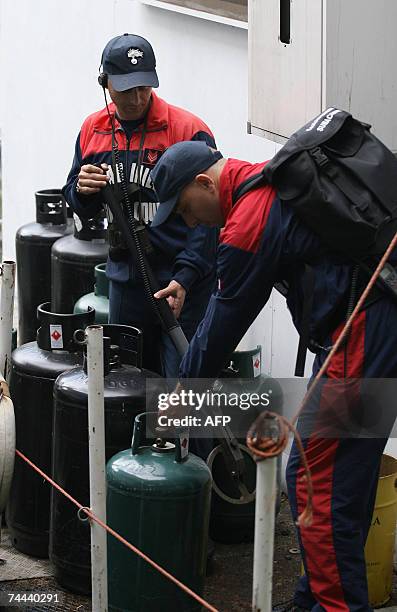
[180,159,351,378]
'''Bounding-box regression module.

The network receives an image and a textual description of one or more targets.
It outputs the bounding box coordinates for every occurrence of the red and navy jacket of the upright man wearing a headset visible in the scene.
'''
[63,92,218,291]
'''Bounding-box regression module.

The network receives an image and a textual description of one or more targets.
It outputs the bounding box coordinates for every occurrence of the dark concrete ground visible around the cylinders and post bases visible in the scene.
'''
[0,498,397,612]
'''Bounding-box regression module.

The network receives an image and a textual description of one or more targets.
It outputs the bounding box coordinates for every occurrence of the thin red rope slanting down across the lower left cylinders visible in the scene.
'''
[15,449,219,612]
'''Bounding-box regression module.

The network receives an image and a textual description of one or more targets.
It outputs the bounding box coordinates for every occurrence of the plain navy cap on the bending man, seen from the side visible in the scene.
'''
[150,140,223,227]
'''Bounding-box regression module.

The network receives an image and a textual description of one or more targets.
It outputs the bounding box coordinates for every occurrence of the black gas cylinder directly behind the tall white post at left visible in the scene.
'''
[50,325,158,594]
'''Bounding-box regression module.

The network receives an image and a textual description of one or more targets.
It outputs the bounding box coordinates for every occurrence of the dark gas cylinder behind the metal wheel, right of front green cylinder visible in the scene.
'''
[207,346,283,544]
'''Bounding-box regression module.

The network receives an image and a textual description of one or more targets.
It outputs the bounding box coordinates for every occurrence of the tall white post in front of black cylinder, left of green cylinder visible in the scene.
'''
[86,325,108,612]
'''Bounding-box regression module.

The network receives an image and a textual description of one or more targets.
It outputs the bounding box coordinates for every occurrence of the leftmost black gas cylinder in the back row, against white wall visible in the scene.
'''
[15,189,73,344]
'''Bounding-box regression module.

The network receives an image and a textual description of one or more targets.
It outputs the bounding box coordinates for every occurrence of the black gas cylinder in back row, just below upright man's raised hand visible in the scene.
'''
[51,213,109,313]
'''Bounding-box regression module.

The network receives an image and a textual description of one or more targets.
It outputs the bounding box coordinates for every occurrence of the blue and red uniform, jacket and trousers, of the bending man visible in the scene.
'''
[180,159,397,612]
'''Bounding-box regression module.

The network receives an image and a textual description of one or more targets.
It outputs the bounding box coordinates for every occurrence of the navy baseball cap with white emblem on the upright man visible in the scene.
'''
[101,34,159,91]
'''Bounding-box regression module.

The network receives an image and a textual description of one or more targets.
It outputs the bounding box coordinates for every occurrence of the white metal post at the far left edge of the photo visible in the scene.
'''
[0,261,15,382]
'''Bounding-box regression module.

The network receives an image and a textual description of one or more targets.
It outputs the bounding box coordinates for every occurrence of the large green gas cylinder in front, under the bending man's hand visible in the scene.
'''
[107,413,211,612]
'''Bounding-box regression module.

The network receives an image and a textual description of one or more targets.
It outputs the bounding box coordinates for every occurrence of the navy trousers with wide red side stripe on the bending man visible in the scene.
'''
[287,299,397,612]
